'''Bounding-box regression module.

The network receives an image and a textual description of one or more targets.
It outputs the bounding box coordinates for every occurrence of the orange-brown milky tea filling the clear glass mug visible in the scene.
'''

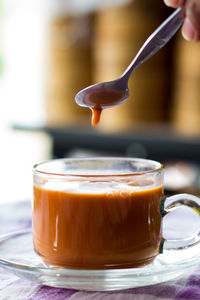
[33,186,163,269]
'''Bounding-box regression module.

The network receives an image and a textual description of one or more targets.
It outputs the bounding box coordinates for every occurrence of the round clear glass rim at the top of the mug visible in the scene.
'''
[32,156,164,178]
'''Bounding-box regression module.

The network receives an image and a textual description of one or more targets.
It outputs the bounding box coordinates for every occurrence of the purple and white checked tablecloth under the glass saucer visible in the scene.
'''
[0,201,200,300]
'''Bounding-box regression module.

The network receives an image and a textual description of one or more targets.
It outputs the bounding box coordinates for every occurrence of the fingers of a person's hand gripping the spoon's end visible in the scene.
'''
[164,0,200,42]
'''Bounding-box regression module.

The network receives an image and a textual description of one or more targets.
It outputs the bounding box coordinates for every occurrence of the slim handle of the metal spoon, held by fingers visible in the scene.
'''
[121,8,184,80]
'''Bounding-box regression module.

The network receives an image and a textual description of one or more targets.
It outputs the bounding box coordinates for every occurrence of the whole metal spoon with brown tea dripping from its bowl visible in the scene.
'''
[75,8,184,124]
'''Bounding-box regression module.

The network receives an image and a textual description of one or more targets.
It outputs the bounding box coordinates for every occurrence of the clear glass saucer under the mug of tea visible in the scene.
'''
[0,230,200,291]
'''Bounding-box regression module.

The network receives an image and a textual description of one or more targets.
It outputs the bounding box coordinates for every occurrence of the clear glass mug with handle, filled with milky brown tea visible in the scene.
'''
[33,157,200,269]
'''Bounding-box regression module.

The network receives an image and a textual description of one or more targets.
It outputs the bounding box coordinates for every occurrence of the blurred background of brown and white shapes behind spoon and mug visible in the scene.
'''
[0,0,200,202]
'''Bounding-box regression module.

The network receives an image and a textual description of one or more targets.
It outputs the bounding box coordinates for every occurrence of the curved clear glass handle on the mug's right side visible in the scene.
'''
[159,194,200,253]
